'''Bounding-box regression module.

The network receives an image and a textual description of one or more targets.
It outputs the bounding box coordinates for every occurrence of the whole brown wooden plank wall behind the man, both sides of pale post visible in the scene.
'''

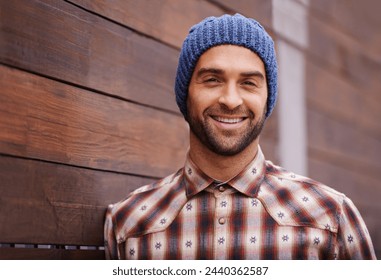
[0,0,381,259]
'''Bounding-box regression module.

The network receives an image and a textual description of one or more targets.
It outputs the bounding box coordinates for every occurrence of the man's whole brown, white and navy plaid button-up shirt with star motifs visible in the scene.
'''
[105,149,376,259]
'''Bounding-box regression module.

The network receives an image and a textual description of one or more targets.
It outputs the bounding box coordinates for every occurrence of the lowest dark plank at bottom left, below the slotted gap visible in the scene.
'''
[0,248,105,260]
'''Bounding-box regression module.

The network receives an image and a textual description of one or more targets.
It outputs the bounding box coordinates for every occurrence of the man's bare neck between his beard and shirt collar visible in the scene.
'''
[189,135,258,182]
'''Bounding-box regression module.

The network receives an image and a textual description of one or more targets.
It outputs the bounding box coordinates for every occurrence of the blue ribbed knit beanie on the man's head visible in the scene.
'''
[175,14,278,118]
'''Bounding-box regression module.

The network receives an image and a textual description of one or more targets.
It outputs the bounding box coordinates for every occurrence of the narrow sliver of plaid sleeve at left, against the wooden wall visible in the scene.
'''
[104,205,118,260]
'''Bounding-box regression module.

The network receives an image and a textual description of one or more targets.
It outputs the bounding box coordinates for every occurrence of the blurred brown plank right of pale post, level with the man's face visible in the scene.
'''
[306,61,381,139]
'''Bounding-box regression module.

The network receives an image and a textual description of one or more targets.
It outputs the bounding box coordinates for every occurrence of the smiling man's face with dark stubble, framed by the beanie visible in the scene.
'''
[187,45,267,156]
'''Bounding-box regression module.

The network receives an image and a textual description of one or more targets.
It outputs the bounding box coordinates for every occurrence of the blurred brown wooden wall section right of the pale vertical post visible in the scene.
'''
[305,0,381,258]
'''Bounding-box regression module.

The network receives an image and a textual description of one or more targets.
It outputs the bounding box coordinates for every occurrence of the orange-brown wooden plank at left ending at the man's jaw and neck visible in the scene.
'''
[0,66,188,177]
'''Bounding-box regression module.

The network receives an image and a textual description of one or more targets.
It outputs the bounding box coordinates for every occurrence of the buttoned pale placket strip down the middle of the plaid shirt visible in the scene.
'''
[213,185,231,259]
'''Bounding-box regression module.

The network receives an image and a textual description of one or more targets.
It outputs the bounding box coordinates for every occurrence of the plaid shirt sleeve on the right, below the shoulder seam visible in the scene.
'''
[338,197,376,260]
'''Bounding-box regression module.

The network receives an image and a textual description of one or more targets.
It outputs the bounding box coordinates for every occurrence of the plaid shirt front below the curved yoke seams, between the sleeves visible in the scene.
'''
[120,195,337,259]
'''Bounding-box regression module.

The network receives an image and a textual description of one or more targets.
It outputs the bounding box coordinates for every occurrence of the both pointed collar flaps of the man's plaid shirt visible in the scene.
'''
[184,146,266,198]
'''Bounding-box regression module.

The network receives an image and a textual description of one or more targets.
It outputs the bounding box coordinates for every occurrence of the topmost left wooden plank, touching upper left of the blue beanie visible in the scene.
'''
[69,0,223,47]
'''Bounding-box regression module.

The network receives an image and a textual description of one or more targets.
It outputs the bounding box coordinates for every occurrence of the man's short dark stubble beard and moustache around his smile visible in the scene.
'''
[187,105,266,156]
